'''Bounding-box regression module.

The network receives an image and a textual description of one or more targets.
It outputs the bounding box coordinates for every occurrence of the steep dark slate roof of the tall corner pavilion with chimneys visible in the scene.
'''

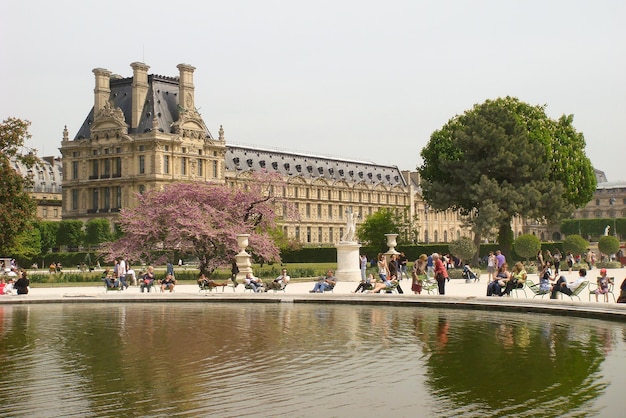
[74,74,213,140]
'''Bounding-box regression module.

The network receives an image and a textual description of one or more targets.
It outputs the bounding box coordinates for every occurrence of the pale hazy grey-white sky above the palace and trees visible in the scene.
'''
[0,0,626,181]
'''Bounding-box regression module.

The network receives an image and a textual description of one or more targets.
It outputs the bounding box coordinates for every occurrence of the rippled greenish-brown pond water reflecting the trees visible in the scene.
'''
[0,302,626,417]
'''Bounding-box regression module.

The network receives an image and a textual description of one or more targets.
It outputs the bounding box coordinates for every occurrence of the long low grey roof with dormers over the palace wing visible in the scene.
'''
[225,145,407,187]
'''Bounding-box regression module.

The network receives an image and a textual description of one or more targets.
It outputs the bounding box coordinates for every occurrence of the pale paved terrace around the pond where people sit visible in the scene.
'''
[0,269,626,321]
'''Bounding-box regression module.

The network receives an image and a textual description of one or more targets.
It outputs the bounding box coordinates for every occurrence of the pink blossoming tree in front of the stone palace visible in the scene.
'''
[105,173,290,274]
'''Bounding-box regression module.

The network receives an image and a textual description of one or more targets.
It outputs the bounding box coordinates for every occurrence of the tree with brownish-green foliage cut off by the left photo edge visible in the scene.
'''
[0,118,37,256]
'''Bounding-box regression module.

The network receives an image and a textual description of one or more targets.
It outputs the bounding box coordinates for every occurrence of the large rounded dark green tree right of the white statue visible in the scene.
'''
[418,97,596,258]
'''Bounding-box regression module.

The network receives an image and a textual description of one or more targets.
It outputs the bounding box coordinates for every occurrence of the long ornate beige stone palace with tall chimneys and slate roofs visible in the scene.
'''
[60,62,616,246]
